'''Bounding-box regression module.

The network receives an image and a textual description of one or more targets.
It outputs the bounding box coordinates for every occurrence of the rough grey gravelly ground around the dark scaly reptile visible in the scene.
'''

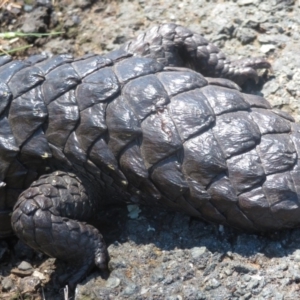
[0,0,300,300]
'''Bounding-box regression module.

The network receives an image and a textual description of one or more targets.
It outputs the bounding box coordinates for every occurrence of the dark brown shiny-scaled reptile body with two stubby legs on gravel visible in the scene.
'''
[0,24,300,285]
